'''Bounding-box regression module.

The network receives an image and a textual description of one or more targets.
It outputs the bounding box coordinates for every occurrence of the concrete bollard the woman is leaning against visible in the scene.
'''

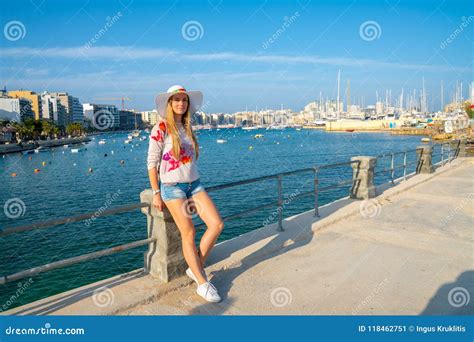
[140,189,188,282]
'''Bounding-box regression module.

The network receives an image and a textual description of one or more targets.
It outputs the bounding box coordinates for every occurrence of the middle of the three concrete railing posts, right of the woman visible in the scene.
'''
[350,156,377,199]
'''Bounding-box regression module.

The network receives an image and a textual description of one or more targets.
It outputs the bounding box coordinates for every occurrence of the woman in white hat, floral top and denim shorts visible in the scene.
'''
[147,85,224,302]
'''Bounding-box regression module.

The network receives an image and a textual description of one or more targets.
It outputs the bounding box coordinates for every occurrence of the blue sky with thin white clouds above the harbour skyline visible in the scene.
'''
[0,0,474,112]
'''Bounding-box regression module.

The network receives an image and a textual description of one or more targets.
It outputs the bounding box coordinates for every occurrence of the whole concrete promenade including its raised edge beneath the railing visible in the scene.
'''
[4,158,474,315]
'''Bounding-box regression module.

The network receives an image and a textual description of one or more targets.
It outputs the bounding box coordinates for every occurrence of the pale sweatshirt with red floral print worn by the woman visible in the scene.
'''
[147,120,199,183]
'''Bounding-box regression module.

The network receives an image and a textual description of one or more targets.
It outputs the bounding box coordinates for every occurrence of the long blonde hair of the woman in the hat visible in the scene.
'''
[165,94,199,160]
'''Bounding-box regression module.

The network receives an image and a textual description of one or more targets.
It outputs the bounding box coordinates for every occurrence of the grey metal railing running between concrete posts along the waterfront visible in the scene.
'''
[0,141,459,284]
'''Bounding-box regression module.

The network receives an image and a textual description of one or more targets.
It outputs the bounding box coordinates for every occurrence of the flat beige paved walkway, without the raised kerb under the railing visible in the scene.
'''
[124,159,474,315]
